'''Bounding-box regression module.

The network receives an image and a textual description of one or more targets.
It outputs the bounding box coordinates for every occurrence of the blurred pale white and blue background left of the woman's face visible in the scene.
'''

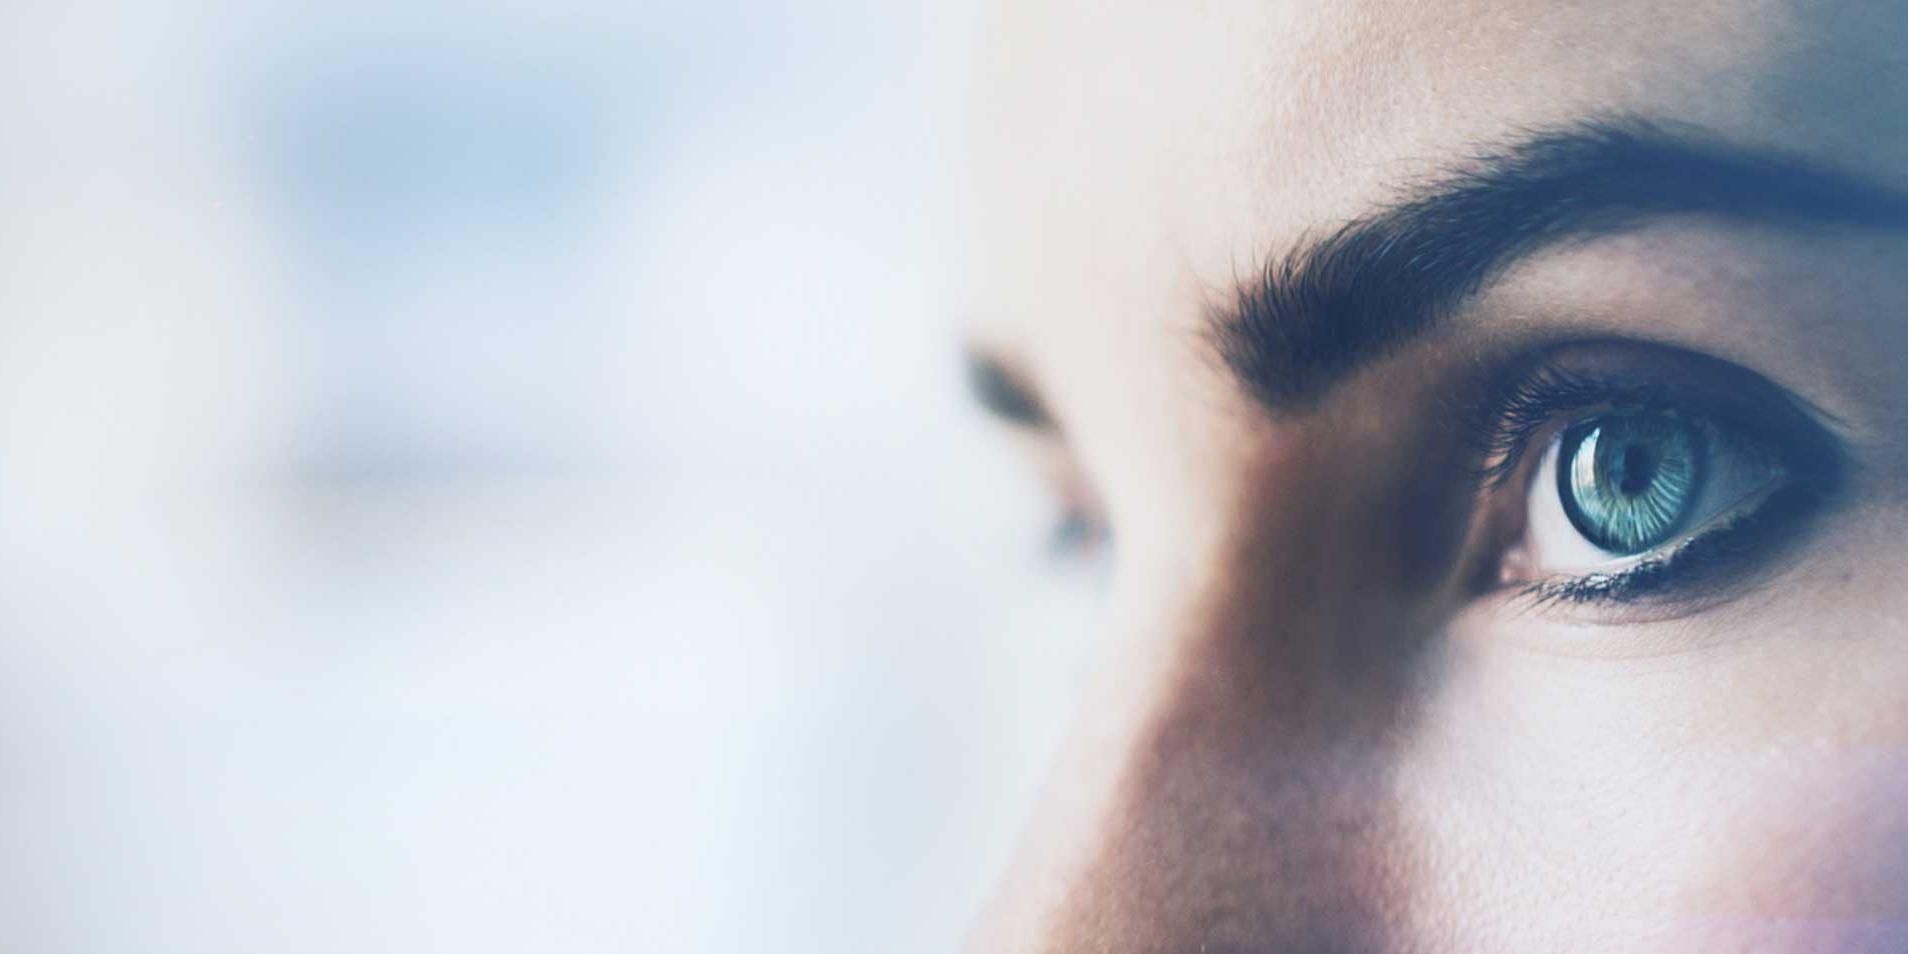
[0,0,1091,952]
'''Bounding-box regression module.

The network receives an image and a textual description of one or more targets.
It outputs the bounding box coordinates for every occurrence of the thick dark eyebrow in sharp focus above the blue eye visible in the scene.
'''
[1208,120,1908,412]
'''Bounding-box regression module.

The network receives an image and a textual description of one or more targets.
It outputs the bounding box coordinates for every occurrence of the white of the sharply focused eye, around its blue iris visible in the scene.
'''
[1523,427,1782,576]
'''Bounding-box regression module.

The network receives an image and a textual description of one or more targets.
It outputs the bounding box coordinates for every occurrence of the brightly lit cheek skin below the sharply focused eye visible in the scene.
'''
[1399,616,1908,950]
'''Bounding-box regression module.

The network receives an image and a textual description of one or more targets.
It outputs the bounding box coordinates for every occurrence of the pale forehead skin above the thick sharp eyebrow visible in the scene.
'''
[975,0,1908,331]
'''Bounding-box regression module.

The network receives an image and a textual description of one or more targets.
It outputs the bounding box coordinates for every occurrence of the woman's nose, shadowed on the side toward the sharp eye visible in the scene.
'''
[979,414,1460,952]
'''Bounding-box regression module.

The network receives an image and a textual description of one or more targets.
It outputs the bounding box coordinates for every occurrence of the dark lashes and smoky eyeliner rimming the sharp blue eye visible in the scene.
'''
[1467,361,1841,605]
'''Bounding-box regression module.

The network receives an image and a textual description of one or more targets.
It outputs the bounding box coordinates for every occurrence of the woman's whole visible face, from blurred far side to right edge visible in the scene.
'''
[967,0,1908,952]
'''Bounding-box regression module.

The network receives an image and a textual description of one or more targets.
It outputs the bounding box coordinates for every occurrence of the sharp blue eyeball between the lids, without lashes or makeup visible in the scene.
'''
[1526,410,1788,576]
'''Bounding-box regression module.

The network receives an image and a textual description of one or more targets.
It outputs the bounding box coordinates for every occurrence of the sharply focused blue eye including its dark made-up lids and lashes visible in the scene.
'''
[1473,342,1843,603]
